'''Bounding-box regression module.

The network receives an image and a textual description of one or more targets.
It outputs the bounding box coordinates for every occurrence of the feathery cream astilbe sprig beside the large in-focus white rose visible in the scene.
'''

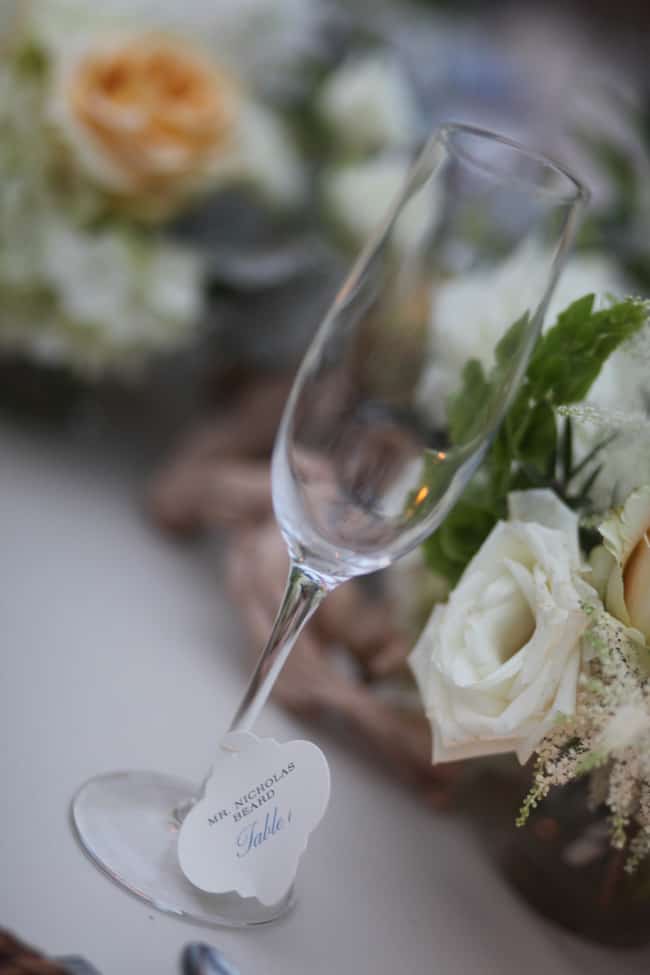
[518,606,650,871]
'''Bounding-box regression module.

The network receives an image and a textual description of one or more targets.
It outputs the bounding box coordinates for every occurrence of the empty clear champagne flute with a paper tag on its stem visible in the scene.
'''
[72,124,587,926]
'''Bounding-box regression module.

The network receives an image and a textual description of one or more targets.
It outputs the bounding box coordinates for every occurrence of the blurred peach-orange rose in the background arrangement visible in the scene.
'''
[49,33,240,212]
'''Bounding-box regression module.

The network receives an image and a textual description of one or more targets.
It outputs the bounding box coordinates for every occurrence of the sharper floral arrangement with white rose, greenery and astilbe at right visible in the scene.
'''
[410,295,650,936]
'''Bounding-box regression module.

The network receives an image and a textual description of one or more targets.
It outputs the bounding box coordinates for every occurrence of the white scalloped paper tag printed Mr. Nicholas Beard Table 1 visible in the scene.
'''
[178,732,330,904]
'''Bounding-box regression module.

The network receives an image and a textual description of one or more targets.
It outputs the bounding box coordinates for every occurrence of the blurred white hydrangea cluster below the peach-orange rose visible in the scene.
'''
[0,216,201,376]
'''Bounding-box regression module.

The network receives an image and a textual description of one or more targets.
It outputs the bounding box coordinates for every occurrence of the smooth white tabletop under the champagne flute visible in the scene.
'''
[0,425,650,975]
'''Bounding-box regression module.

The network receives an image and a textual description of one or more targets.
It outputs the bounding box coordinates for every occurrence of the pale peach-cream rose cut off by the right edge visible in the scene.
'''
[591,485,650,646]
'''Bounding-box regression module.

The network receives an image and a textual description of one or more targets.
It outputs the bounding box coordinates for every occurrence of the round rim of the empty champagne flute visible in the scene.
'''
[432,122,591,204]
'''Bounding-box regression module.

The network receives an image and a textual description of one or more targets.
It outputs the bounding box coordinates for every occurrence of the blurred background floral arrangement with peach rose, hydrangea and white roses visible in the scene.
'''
[0,0,428,388]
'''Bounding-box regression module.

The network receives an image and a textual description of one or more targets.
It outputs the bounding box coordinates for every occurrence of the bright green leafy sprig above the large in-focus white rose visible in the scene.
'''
[424,295,648,585]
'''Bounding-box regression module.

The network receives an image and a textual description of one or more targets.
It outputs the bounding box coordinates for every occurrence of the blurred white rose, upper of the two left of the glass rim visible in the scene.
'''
[318,55,416,152]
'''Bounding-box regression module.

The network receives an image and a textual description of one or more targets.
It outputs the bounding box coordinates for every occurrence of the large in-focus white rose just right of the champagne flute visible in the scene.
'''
[410,490,596,763]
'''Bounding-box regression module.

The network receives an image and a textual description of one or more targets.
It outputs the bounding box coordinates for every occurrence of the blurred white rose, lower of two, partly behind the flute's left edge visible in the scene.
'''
[323,153,438,250]
